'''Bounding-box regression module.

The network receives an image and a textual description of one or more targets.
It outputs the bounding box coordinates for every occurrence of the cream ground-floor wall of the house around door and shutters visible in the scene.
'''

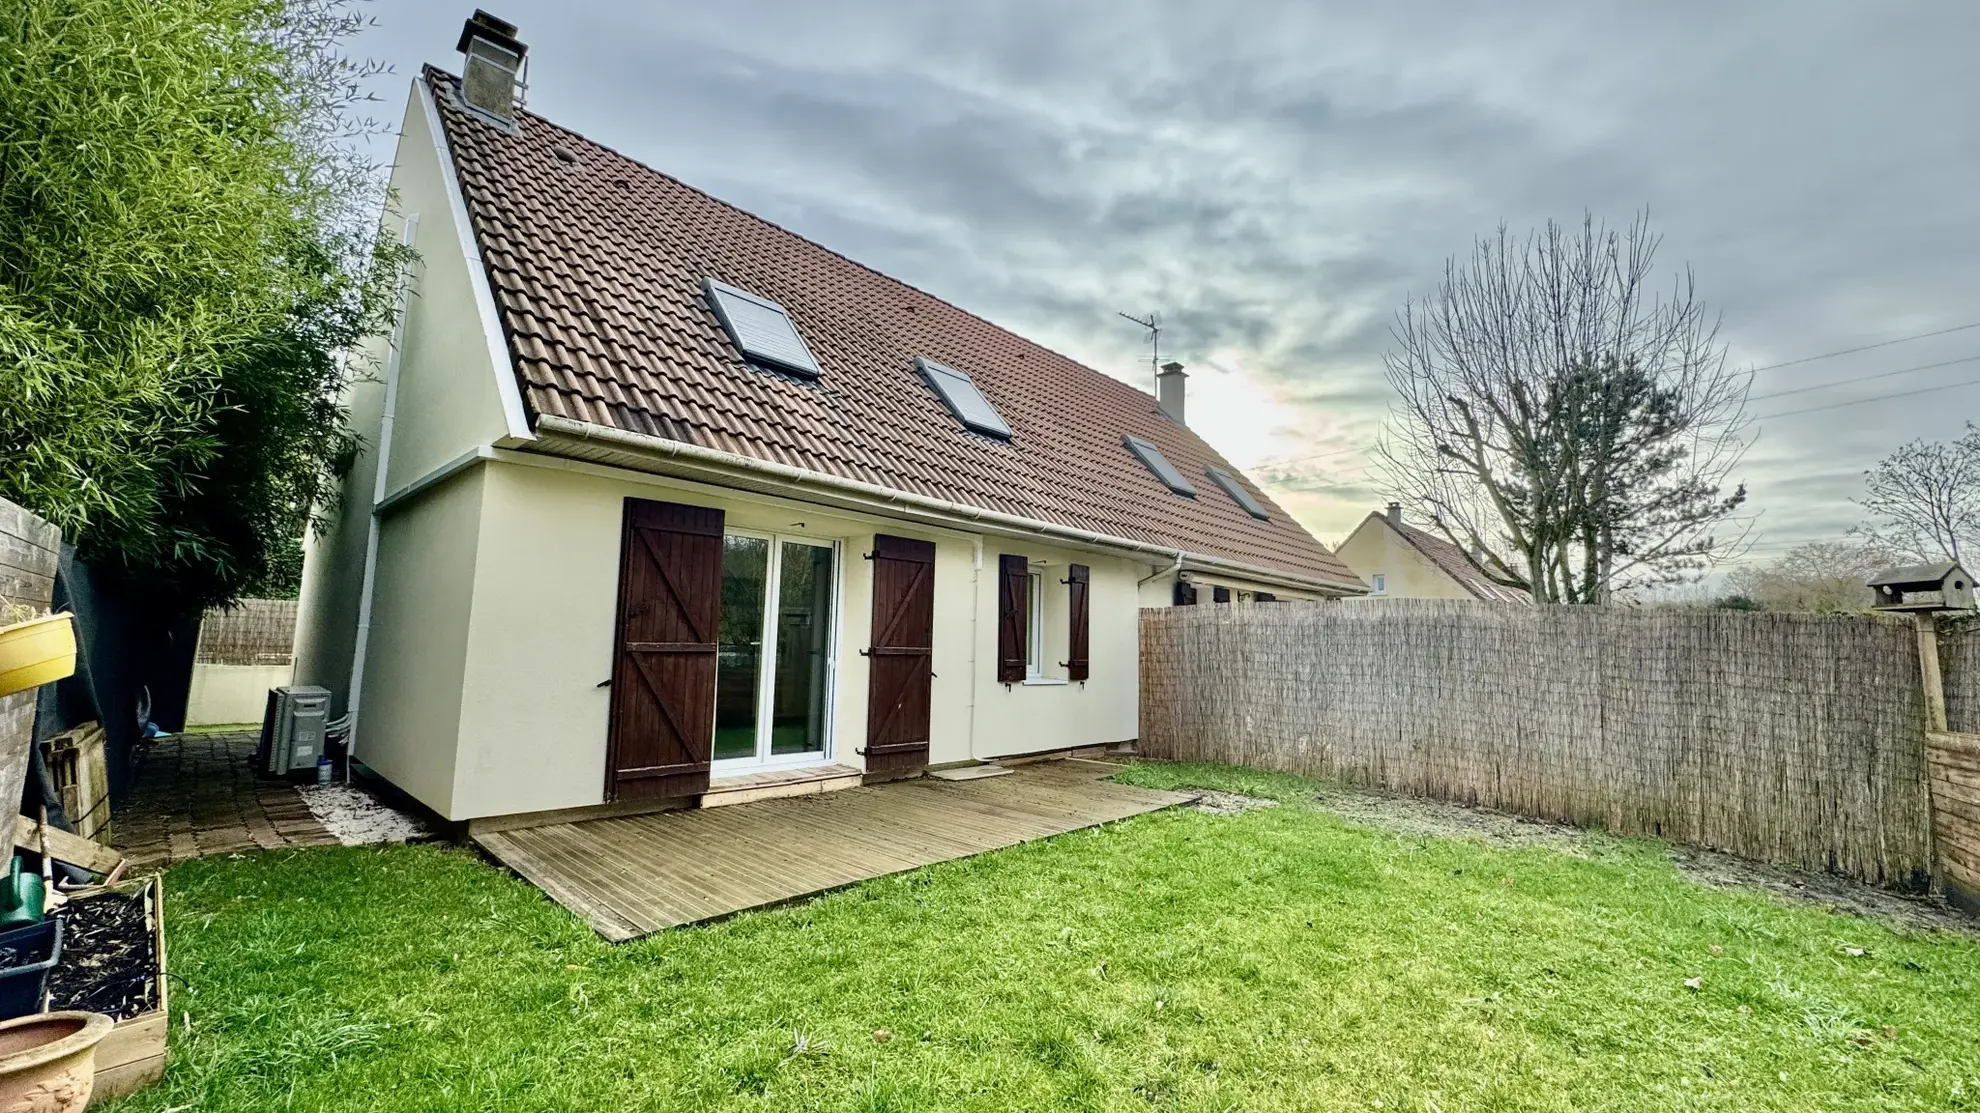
[382,457,1150,818]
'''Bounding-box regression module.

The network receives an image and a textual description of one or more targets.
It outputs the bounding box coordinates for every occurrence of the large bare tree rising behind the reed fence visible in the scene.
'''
[1378,214,1750,602]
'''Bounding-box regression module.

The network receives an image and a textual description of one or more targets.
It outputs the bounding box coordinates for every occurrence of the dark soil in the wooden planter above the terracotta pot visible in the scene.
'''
[48,891,158,1020]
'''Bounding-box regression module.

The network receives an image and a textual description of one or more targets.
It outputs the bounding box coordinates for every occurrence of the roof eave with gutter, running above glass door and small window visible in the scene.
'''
[531,414,1368,596]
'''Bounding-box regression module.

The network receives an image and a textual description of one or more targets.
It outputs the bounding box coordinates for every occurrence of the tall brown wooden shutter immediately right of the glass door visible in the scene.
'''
[863,535,935,772]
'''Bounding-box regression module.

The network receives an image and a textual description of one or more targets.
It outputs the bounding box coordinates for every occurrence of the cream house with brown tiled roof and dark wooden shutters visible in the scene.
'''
[297,18,1366,820]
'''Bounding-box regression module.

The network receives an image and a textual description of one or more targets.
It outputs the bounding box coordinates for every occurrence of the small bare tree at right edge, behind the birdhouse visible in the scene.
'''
[1857,422,1980,560]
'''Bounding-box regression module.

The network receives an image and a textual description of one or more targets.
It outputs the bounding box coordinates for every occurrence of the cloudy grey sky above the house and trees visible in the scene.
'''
[354,0,1980,557]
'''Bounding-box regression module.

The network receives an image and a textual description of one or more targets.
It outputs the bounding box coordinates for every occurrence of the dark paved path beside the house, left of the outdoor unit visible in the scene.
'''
[111,733,337,865]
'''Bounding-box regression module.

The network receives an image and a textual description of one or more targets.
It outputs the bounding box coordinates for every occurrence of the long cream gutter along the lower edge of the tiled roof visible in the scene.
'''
[537,414,1368,596]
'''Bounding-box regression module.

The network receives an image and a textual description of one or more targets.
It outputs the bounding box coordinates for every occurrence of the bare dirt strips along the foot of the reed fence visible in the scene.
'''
[1313,786,1980,937]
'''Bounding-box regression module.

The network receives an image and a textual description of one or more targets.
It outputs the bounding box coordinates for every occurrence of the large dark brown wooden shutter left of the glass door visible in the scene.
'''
[606,499,723,800]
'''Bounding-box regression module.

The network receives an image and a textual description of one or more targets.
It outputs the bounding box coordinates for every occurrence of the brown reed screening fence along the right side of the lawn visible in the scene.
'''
[1140,600,1950,887]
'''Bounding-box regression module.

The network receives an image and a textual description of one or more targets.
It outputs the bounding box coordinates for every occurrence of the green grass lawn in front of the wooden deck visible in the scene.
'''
[121,766,1980,1113]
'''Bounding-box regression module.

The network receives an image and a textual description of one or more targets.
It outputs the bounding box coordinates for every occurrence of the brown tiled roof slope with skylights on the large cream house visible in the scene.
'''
[426,67,1358,584]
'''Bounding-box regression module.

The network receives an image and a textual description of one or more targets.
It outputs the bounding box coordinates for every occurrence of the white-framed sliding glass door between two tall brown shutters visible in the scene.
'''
[715,533,838,774]
